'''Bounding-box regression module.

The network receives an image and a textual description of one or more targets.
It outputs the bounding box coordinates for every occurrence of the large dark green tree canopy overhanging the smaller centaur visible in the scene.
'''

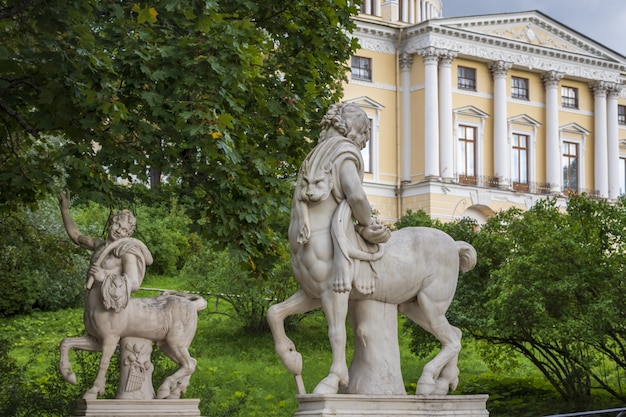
[0,0,356,270]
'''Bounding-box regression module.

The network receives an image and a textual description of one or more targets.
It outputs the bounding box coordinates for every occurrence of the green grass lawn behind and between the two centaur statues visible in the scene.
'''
[0,277,618,417]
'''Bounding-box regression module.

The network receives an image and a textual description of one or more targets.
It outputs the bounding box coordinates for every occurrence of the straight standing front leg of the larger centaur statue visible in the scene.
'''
[313,289,350,394]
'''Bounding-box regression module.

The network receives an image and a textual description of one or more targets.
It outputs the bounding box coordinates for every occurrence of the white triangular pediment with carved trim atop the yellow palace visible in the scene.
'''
[394,11,626,83]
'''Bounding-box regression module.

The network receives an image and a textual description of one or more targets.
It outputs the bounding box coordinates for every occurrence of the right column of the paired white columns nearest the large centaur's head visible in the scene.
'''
[439,51,456,180]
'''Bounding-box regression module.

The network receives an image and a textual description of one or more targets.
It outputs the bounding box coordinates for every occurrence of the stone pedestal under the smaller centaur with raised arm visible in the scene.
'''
[75,399,200,417]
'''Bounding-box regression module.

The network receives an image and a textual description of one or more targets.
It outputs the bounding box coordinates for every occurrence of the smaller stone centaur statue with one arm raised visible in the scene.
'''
[59,194,207,399]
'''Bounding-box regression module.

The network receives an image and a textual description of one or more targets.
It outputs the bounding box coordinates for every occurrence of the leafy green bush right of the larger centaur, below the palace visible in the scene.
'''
[451,196,626,402]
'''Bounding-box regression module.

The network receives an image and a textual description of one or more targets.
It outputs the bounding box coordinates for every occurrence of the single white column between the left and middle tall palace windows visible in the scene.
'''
[489,61,511,188]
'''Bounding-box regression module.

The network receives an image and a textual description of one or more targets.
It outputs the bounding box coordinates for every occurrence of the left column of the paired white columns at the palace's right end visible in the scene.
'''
[589,81,609,198]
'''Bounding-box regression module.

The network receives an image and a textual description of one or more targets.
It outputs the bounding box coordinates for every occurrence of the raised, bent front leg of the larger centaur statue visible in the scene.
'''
[267,290,322,394]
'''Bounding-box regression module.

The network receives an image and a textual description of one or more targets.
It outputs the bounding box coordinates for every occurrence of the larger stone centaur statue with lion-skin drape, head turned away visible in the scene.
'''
[268,103,476,395]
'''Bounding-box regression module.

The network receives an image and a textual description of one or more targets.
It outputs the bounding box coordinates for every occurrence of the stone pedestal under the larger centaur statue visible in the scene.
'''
[294,394,489,417]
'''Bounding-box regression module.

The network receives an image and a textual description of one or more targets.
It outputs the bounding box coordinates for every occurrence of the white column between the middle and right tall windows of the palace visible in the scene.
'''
[541,71,563,194]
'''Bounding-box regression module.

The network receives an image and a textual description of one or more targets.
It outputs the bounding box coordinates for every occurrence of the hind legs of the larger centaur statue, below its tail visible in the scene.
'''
[399,292,461,395]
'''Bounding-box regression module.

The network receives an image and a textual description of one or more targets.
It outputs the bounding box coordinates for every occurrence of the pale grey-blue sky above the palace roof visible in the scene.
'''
[442,0,626,56]
